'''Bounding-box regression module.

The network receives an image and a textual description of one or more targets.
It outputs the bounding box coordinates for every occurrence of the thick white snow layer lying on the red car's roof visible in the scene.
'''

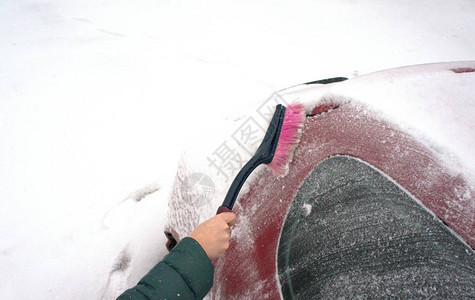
[279,61,475,185]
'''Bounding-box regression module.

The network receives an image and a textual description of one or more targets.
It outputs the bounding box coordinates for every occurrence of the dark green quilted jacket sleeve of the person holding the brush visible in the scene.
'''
[117,237,214,300]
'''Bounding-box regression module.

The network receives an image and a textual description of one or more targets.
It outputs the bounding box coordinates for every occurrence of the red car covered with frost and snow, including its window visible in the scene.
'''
[166,61,475,299]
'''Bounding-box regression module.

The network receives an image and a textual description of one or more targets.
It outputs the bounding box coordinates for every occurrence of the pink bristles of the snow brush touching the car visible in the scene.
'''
[269,102,305,177]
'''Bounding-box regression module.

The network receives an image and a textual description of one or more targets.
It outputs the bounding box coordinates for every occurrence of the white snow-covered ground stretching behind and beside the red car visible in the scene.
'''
[0,0,475,299]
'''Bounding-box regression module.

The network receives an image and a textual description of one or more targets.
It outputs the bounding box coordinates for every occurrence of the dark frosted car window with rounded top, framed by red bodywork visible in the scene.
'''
[278,156,475,299]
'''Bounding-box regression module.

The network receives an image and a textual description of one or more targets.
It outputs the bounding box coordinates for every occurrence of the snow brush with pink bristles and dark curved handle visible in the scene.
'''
[216,103,305,214]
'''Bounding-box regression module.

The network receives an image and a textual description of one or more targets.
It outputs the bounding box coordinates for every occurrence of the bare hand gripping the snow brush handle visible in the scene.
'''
[190,212,236,259]
